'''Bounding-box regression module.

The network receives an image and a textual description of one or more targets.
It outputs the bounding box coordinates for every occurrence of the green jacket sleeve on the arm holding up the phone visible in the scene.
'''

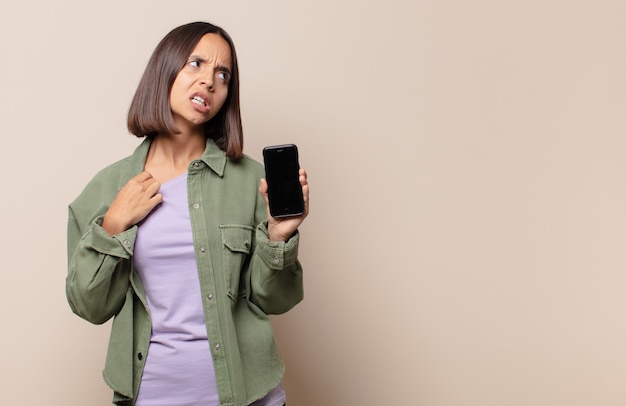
[248,192,304,314]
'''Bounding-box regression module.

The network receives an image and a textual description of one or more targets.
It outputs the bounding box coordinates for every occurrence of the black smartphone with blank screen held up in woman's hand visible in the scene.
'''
[263,144,304,217]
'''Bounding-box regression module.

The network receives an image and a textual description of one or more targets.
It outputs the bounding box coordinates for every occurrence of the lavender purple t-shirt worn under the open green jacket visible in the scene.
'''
[133,174,285,406]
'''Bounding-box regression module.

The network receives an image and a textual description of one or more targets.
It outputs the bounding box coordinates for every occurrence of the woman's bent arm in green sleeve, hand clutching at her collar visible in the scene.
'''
[66,172,163,324]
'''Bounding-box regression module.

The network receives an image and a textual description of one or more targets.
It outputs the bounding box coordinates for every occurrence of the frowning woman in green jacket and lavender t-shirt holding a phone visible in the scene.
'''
[66,22,308,406]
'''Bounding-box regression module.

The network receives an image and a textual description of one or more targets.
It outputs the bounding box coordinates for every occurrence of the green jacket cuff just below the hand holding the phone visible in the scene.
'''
[256,222,300,271]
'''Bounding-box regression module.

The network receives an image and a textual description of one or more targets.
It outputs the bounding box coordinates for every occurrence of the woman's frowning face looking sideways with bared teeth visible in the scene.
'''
[170,34,232,132]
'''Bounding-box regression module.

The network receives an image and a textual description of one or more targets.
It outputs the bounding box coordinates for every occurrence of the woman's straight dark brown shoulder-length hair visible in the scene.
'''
[127,22,243,159]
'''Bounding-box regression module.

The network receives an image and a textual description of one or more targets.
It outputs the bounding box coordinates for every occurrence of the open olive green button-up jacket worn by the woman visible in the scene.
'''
[66,138,303,406]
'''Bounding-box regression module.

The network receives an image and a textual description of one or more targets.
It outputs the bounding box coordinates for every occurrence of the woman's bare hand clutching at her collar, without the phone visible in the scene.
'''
[102,171,163,236]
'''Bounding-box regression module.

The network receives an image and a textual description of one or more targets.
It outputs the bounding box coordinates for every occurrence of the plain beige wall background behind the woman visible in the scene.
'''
[0,0,626,406]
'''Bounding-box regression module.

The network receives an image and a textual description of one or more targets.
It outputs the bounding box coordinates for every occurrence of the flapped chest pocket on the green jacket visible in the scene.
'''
[220,224,254,301]
